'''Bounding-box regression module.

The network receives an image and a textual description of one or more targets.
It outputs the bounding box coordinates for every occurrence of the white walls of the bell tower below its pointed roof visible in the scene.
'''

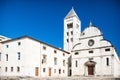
[64,16,81,52]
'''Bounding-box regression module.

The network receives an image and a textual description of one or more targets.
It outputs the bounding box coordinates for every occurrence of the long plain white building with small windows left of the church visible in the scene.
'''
[0,36,69,78]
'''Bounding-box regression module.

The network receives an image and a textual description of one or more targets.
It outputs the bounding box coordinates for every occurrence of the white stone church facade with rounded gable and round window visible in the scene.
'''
[72,24,120,76]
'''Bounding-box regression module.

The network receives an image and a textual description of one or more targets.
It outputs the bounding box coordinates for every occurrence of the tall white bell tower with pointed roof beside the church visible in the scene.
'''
[64,7,81,52]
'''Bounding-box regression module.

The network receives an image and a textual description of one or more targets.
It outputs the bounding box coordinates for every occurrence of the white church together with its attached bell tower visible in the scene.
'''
[64,8,120,76]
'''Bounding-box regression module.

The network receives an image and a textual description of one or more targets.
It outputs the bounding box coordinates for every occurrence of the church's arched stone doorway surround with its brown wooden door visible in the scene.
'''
[85,61,96,75]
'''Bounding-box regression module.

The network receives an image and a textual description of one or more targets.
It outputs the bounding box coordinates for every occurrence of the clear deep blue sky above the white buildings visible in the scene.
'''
[0,0,120,55]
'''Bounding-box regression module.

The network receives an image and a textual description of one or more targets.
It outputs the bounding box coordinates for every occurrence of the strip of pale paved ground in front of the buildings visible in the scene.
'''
[0,77,120,80]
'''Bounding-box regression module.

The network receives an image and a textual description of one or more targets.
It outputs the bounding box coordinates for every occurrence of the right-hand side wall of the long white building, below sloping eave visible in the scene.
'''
[41,44,68,77]
